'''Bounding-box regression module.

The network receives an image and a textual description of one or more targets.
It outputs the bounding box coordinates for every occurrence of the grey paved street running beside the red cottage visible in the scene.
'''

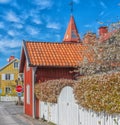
[0,102,48,125]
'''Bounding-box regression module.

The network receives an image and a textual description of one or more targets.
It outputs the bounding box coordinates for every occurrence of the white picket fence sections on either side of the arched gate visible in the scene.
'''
[40,102,120,125]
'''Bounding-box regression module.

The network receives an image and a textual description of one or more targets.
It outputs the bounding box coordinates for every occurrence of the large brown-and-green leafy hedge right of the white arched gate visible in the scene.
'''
[74,73,120,114]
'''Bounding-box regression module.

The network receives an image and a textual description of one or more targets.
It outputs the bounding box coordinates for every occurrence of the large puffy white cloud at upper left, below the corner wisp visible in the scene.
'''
[5,11,20,22]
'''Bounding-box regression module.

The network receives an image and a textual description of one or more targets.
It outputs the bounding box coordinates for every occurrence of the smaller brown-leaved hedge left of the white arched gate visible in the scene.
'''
[35,79,76,103]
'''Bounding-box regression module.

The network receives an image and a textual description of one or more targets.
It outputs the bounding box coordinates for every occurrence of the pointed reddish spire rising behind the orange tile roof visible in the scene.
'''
[63,15,80,43]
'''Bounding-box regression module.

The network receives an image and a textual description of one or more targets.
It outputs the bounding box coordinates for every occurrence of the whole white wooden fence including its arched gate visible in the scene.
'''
[39,87,120,125]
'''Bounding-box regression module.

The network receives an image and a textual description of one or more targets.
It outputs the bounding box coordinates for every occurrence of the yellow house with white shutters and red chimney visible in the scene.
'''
[0,56,22,96]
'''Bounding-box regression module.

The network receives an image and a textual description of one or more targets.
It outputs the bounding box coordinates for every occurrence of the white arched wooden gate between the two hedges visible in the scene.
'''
[58,86,78,125]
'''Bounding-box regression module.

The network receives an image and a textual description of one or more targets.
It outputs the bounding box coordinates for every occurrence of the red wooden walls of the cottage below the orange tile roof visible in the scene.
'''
[24,64,74,118]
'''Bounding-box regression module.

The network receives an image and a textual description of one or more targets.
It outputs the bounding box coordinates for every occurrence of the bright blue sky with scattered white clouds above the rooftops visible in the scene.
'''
[0,0,120,67]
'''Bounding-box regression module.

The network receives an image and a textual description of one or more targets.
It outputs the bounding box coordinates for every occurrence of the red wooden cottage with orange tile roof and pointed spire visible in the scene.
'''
[20,16,91,118]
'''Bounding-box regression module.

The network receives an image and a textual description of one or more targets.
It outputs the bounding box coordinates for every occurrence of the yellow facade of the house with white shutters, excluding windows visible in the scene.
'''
[0,60,22,96]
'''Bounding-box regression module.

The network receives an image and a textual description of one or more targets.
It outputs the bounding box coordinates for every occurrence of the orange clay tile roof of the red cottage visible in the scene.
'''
[24,41,92,67]
